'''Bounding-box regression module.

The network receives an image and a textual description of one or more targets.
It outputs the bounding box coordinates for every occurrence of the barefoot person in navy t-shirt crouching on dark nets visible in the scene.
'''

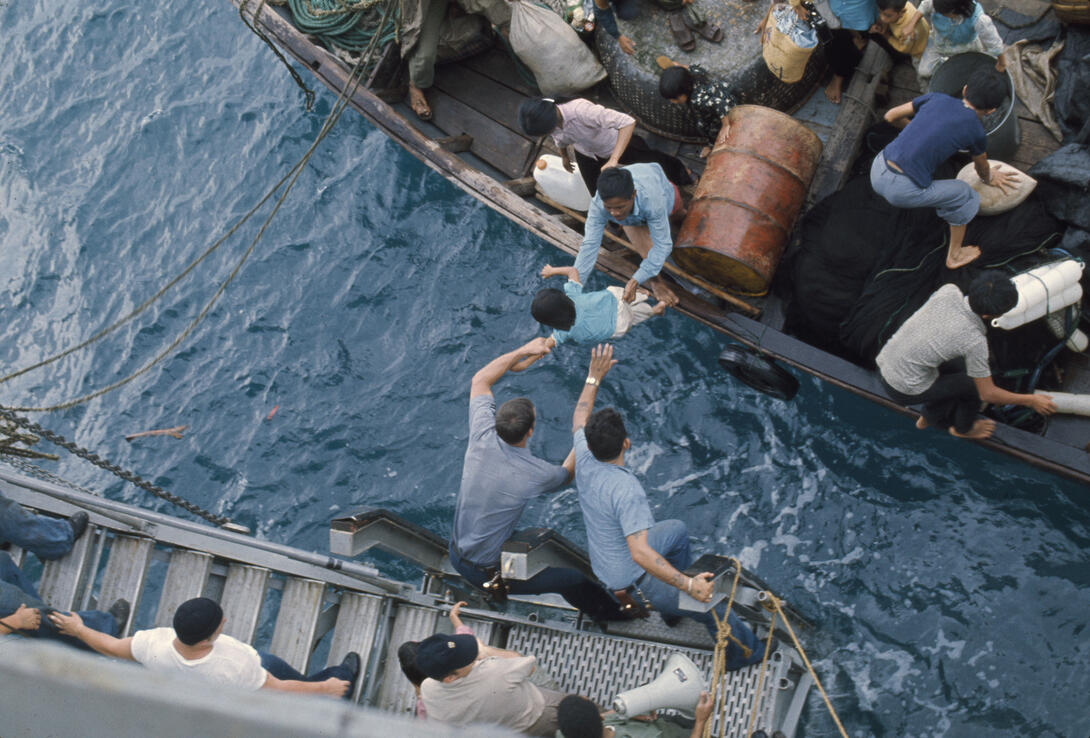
[871,70,1015,269]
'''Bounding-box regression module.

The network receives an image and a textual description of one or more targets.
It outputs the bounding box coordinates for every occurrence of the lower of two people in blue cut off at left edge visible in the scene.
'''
[0,554,131,649]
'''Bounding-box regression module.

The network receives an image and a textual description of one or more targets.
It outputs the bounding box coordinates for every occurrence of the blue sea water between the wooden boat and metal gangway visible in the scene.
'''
[0,0,1090,737]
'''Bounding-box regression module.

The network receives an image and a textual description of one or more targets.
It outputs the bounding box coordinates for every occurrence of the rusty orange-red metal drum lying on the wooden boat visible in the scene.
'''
[674,105,822,295]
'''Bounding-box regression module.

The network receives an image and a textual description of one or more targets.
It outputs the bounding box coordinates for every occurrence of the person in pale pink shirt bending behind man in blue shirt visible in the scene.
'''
[519,97,692,192]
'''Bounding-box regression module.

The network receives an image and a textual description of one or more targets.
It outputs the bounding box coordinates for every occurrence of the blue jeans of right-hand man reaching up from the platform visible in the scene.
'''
[637,520,764,672]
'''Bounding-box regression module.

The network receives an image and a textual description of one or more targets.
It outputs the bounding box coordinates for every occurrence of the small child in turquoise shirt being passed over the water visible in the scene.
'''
[522,264,666,355]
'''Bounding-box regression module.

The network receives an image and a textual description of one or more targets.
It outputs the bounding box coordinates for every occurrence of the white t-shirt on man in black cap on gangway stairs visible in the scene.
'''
[132,628,268,690]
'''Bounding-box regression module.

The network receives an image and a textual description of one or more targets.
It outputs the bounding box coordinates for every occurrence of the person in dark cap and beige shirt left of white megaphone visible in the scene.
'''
[416,633,564,736]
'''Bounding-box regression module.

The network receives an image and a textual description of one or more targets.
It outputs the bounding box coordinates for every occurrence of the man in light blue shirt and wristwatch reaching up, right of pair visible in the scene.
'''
[571,344,762,670]
